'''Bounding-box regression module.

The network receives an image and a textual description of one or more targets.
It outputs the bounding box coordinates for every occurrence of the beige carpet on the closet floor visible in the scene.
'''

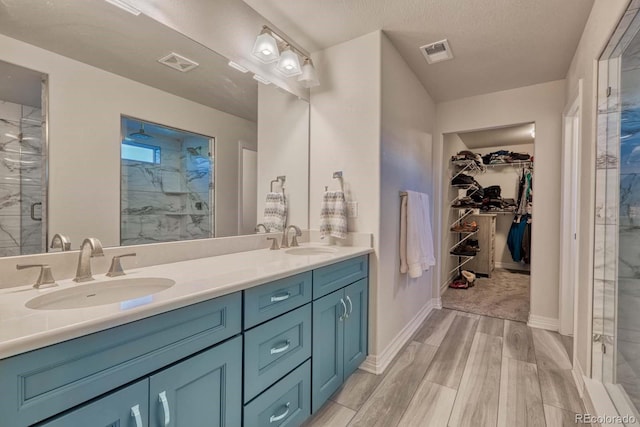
[442,269,530,322]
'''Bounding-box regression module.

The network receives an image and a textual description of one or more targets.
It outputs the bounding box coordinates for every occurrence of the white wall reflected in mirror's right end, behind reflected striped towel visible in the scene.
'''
[257,84,309,229]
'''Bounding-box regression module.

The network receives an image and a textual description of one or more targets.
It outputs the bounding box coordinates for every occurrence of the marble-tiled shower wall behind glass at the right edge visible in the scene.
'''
[592,2,640,408]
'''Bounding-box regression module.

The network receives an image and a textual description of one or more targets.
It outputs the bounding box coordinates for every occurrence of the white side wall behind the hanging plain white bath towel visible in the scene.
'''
[373,34,441,362]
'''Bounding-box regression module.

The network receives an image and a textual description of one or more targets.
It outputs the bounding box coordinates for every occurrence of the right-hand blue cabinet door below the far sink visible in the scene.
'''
[344,279,369,378]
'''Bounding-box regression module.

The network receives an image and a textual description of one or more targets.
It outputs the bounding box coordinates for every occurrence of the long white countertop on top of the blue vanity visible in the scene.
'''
[0,244,373,359]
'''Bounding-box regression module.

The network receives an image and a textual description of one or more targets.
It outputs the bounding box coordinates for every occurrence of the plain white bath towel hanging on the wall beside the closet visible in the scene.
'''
[400,191,436,278]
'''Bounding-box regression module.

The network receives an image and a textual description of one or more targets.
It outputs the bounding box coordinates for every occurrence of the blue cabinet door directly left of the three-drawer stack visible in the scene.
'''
[149,337,242,427]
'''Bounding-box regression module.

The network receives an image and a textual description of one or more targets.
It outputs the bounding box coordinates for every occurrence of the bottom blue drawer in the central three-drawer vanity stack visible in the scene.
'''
[244,360,311,427]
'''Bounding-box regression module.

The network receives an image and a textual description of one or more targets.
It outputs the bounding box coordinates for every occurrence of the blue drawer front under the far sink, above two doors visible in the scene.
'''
[313,255,369,299]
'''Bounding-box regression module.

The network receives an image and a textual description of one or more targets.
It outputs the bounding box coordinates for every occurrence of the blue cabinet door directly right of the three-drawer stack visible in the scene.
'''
[311,289,346,412]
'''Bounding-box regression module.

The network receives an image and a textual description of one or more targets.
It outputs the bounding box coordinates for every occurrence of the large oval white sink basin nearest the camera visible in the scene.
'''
[25,277,176,310]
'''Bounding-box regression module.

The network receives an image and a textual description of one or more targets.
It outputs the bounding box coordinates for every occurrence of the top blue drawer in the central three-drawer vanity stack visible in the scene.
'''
[244,271,311,329]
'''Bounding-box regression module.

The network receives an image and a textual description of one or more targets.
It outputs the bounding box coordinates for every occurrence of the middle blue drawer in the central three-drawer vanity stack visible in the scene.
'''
[244,304,311,403]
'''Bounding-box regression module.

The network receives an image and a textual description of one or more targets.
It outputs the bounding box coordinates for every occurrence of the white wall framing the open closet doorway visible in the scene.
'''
[434,80,565,323]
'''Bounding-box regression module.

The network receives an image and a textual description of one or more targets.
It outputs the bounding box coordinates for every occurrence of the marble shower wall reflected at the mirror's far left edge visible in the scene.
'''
[0,100,46,256]
